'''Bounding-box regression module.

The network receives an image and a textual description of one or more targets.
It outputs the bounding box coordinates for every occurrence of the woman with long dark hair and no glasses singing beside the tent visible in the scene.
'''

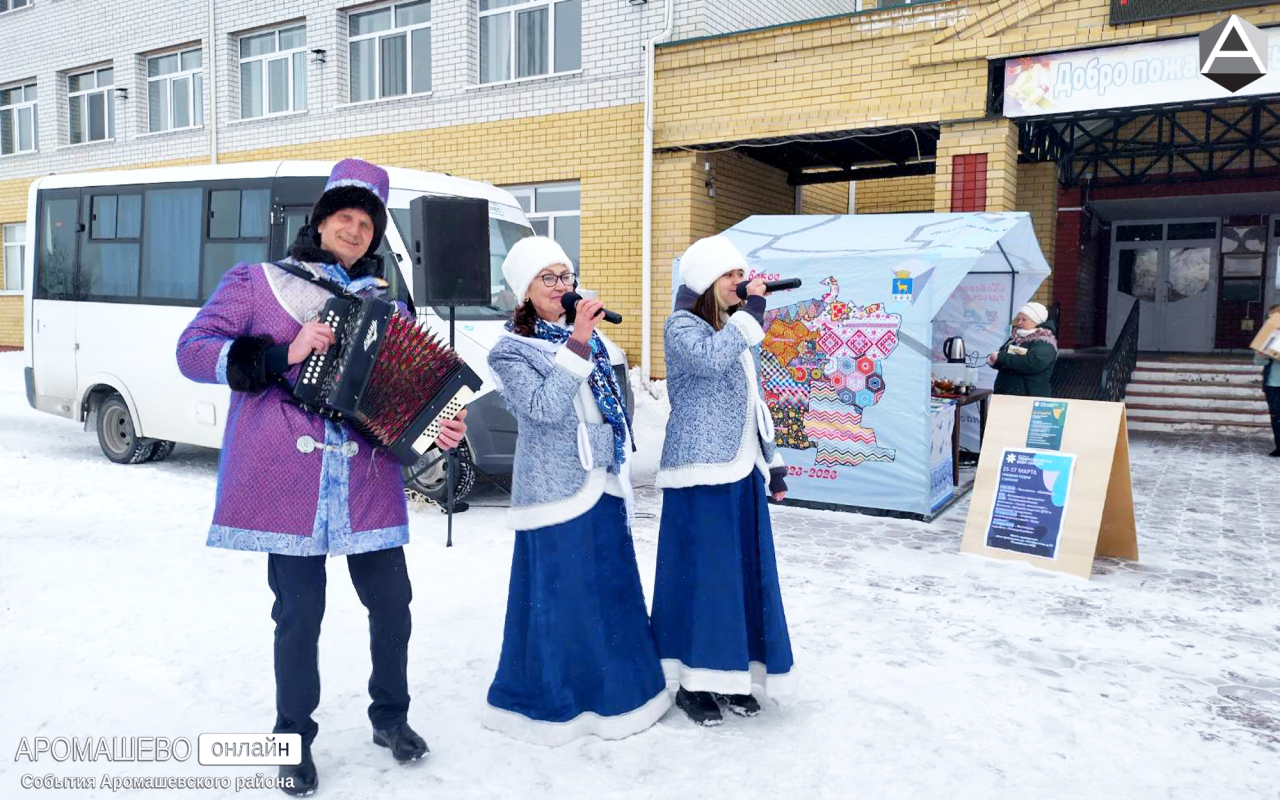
[653,230,791,724]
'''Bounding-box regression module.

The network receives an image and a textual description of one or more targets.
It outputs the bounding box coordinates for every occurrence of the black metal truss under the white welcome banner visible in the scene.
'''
[1019,96,1280,187]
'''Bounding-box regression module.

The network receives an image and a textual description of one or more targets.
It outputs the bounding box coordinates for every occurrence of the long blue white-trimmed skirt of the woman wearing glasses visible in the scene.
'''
[484,494,671,745]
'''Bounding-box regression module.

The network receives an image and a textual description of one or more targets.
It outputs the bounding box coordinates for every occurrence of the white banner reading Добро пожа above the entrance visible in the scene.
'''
[1005,28,1280,118]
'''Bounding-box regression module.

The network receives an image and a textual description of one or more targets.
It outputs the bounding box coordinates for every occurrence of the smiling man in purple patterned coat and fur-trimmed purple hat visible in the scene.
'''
[177,159,466,795]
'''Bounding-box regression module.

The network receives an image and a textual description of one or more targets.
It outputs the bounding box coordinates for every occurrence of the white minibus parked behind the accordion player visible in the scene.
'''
[23,161,631,499]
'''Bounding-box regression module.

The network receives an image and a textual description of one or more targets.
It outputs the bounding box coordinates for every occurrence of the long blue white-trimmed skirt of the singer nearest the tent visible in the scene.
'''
[653,470,794,698]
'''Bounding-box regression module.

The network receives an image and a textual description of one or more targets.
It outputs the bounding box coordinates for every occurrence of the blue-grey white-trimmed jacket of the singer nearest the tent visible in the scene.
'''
[654,287,786,492]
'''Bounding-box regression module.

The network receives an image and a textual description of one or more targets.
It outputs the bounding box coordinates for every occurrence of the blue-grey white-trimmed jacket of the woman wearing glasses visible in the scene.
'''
[489,334,630,530]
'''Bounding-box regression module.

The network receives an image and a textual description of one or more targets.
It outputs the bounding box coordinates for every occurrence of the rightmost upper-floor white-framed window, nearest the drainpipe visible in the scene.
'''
[480,0,582,83]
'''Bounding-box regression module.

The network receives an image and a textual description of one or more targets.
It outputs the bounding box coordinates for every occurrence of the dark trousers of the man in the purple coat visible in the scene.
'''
[266,548,413,748]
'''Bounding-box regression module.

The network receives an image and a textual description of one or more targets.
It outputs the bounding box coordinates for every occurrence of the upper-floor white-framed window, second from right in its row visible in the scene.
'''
[348,0,431,102]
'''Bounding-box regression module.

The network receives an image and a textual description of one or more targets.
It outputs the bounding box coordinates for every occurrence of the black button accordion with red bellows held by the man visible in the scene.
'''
[293,294,483,465]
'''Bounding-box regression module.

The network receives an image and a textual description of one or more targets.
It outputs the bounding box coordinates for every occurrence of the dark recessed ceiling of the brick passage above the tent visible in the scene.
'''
[655,123,941,186]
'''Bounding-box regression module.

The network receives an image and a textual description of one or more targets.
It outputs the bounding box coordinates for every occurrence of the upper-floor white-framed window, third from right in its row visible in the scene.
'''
[239,26,307,119]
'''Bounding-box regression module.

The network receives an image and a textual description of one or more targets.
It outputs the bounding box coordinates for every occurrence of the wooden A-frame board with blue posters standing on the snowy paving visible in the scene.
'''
[960,396,1138,580]
